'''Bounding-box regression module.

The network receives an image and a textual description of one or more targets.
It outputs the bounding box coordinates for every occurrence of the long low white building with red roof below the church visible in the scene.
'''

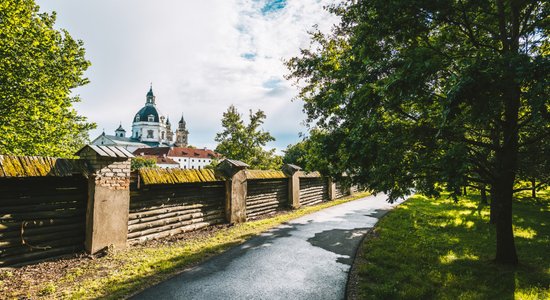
[134,147,220,169]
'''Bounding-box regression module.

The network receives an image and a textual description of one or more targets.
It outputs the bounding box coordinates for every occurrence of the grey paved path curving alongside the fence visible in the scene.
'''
[132,194,404,300]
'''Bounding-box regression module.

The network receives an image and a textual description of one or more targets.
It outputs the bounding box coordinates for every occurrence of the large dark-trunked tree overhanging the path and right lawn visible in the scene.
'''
[288,0,550,264]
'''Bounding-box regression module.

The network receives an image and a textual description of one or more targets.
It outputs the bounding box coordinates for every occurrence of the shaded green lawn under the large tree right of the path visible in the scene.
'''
[354,190,550,299]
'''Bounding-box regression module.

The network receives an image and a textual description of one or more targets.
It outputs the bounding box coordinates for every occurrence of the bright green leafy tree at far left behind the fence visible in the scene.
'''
[0,0,95,157]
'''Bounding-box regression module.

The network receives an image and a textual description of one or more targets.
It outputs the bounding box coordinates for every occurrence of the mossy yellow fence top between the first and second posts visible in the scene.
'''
[139,168,225,184]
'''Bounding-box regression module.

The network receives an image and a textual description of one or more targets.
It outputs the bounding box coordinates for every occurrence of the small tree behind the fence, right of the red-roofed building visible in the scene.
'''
[215,105,282,169]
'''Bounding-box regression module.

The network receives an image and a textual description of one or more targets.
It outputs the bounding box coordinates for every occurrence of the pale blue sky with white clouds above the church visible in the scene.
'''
[36,0,338,153]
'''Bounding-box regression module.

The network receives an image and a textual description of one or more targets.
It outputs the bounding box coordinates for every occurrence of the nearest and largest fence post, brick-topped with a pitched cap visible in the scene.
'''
[77,145,133,254]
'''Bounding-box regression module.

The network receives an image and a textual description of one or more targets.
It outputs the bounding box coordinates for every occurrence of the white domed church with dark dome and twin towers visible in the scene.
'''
[91,86,189,152]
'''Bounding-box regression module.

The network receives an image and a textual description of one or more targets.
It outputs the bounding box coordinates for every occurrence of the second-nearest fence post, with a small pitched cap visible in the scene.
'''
[217,159,248,224]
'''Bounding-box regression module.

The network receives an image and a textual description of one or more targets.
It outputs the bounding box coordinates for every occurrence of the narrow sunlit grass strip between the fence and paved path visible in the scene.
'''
[0,193,374,299]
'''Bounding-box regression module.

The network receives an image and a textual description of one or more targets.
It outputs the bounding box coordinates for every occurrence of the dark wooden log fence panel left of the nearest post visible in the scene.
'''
[0,176,88,267]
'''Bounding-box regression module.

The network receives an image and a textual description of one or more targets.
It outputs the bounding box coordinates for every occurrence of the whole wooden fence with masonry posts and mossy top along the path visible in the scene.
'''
[0,154,362,268]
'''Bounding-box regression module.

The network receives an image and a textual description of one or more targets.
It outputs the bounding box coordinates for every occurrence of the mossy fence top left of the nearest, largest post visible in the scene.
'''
[0,155,89,177]
